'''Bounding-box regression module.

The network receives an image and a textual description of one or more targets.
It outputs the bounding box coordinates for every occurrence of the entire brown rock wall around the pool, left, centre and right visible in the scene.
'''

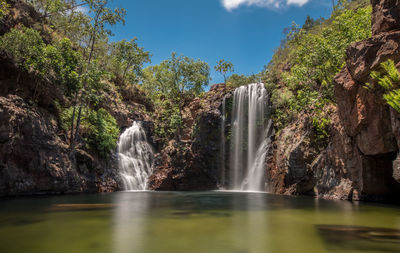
[0,0,400,204]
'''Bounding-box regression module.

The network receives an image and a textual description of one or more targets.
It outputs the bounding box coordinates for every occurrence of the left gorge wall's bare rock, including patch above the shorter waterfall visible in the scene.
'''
[0,0,152,196]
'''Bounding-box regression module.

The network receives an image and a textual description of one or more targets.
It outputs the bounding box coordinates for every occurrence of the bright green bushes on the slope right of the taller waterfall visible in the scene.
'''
[263,0,372,136]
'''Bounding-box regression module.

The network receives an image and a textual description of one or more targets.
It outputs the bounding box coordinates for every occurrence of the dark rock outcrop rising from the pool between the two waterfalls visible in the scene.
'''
[149,84,231,191]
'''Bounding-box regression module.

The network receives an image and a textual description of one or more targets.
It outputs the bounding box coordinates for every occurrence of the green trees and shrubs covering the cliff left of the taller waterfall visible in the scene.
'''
[0,0,216,155]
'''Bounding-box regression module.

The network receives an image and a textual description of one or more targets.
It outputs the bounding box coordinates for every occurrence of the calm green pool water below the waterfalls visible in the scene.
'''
[0,192,400,253]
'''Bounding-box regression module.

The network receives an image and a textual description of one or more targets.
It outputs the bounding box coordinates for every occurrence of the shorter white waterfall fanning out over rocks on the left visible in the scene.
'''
[118,122,153,190]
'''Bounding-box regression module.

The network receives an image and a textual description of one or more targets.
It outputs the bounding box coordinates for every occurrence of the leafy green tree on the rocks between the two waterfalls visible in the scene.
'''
[143,53,210,139]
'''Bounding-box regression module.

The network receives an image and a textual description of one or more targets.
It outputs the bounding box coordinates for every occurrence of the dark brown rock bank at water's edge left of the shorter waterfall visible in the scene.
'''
[0,95,119,195]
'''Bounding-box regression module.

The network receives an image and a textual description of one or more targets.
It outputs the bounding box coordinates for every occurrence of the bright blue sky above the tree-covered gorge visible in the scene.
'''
[108,0,332,84]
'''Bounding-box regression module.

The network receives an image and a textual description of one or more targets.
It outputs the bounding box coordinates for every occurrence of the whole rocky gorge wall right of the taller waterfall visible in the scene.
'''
[267,0,400,201]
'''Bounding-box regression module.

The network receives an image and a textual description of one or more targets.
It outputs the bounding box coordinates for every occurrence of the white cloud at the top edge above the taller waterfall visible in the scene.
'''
[221,0,309,11]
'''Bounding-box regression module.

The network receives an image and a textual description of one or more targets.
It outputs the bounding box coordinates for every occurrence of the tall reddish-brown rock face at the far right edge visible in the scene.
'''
[335,0,400,198]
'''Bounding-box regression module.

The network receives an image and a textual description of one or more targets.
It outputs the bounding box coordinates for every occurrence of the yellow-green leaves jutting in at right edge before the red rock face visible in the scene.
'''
[366,60,400,112]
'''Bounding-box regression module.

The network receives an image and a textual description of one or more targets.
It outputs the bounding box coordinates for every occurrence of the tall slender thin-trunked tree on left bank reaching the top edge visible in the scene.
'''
[70,0,126,151]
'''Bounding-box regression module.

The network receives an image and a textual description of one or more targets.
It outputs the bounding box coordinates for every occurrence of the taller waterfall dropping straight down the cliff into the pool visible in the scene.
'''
[230,83,272,191]
